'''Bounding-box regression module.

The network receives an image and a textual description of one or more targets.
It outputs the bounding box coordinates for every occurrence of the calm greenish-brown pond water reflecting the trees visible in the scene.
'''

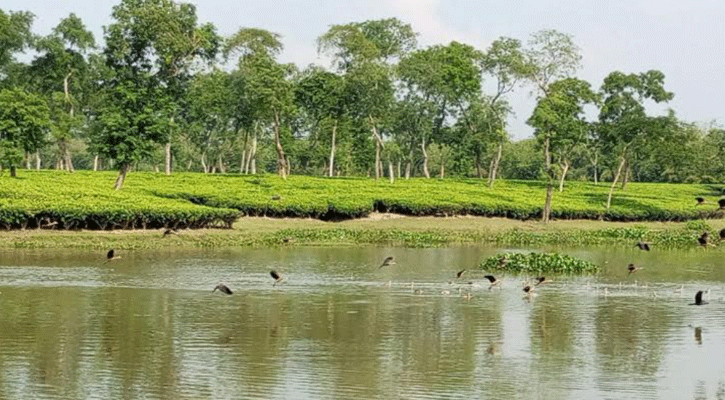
[0,246,725,399]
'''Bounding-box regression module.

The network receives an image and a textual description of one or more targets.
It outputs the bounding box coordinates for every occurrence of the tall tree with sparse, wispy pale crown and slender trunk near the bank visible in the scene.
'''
[525,30,581,222]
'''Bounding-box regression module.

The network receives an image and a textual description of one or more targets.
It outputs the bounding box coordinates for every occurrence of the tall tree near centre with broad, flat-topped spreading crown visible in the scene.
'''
[317,18,416,179]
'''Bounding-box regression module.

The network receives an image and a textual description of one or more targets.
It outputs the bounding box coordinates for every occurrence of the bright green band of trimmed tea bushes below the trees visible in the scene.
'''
[0,171,722,230]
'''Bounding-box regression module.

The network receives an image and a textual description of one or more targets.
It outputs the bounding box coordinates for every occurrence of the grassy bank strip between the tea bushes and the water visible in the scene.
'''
[0,213,725,250]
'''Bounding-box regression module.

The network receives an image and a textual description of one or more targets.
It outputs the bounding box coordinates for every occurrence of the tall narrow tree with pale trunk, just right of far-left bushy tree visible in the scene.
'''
[30,14,95,172]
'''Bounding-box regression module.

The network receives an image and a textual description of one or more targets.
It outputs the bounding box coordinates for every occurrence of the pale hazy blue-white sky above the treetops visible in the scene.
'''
[0,0,725,140]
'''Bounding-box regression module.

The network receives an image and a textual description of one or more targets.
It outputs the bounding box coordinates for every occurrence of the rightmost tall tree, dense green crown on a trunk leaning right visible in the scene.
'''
[599,70,674,210]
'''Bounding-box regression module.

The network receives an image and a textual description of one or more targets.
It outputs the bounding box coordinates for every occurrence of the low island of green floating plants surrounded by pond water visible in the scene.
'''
[480,253,599,274]
